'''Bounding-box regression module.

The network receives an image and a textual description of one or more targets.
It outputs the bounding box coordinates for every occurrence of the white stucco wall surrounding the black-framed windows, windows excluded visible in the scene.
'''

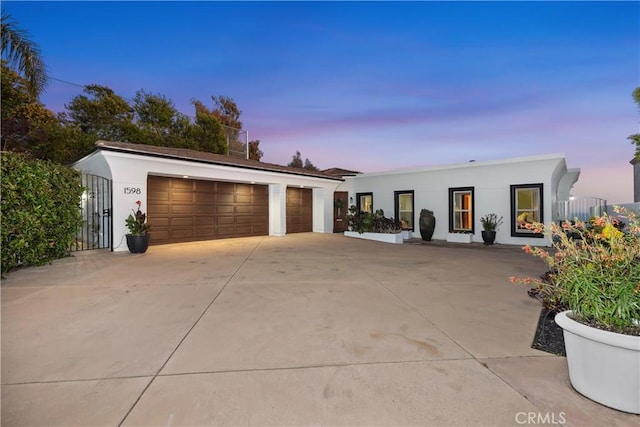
[337,155,579,245]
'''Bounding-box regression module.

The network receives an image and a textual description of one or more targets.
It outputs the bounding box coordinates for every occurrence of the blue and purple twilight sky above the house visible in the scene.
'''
[2,1,640,204]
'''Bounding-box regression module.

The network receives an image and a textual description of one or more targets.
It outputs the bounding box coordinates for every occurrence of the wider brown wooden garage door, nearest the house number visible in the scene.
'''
[147,176,269,245]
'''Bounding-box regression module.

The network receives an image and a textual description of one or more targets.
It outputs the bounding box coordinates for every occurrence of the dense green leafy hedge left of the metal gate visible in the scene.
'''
[0,152,83,273]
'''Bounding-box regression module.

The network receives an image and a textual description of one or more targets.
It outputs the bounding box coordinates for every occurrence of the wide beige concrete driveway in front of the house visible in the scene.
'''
[2,233,639,426]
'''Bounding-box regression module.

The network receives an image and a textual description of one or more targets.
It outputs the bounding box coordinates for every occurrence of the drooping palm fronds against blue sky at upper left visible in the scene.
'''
[0,11,48,97]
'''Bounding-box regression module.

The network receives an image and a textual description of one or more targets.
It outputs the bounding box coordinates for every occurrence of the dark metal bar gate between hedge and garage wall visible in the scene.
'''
[71,173,113,251]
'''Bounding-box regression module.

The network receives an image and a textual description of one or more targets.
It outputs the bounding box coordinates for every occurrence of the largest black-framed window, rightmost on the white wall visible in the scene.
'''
[511,184,543,237]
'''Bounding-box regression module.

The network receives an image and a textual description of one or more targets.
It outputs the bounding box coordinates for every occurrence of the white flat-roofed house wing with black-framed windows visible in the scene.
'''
[336,154,580,245]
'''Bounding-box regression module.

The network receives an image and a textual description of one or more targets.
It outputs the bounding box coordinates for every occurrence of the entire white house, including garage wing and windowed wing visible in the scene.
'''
[74,141,580,251]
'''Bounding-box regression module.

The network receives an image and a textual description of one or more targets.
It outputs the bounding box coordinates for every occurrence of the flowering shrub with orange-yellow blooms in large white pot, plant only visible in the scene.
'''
[511,207,640,335]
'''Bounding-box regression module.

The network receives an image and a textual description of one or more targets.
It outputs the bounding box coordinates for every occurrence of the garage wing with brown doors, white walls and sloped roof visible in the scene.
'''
[74,141,342,251]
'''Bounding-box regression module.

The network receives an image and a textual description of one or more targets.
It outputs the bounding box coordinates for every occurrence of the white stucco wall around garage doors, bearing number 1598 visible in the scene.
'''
[74,150,341,251]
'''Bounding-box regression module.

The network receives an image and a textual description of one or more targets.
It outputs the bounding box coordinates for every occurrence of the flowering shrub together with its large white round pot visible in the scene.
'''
[512,208,640,414]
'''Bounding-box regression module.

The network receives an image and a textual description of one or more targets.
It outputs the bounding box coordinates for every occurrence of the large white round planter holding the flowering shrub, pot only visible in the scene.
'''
[555,311,640,414]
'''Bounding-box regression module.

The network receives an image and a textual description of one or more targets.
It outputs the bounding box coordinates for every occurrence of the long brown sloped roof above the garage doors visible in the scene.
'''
[94,141,342,181]
